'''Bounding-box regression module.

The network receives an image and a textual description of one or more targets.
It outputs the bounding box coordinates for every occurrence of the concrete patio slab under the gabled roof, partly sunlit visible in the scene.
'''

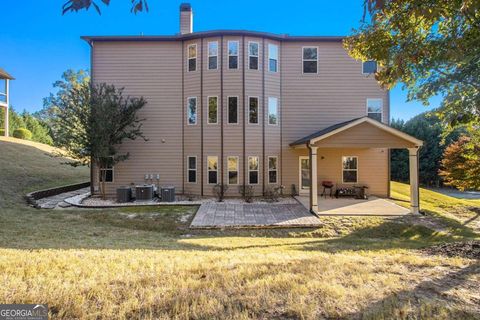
[296,196,410,216]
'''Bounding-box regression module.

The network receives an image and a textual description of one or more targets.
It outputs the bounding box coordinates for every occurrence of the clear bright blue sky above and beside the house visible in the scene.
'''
[0,0,440,119]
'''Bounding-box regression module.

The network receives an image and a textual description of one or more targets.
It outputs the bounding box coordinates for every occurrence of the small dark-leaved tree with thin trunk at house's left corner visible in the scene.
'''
[54,76,147,198]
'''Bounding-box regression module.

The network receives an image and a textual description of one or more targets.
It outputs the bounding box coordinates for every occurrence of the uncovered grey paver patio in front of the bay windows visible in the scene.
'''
[190,202,321,228]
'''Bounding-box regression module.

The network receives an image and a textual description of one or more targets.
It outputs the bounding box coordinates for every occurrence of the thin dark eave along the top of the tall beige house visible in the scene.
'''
[81,30,344,42]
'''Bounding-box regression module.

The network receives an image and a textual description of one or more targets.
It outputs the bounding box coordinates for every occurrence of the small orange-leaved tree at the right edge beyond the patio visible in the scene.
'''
[440,136,480,191]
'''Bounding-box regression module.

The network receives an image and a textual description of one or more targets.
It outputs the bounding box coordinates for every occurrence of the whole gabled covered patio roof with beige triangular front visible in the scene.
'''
[290,117,423,148]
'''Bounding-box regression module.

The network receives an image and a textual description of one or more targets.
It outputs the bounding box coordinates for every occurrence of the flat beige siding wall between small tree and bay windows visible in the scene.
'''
[92,42,183,196]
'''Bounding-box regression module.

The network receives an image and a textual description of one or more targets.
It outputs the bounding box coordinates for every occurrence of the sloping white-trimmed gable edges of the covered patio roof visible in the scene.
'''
[290,117,423,147]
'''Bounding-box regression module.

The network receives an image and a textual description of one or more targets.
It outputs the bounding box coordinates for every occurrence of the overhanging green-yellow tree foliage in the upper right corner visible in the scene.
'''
[344,0,480,125]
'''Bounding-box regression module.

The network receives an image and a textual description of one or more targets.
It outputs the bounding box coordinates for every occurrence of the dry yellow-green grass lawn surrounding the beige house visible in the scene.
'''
[0,141,480,319]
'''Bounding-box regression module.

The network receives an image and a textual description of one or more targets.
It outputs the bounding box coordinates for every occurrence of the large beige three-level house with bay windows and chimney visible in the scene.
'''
[82,4,422,212]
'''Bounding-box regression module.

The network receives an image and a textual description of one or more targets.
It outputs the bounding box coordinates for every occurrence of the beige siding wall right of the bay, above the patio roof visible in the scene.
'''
[279,42,389,191]
